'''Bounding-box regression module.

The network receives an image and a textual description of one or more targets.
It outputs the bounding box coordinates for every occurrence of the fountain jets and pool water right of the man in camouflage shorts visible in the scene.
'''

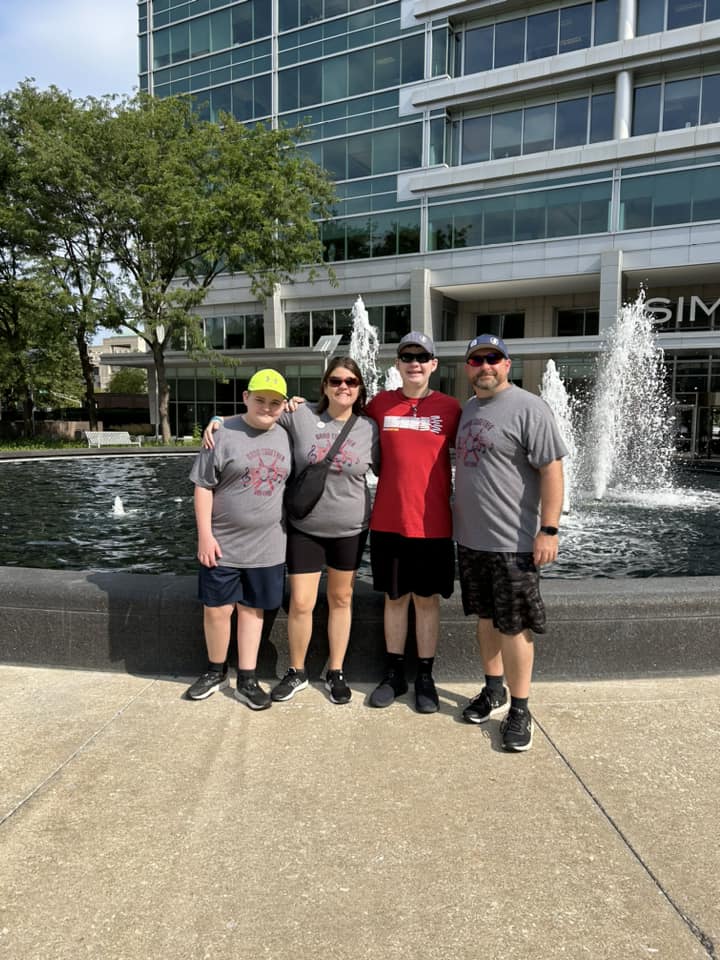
[541,290,720,577]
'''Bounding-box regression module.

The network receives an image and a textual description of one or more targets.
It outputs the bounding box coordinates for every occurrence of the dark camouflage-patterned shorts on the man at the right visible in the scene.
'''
[458,544,545,636]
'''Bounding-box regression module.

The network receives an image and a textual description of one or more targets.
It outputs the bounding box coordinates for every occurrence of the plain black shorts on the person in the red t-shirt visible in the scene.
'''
[370,530,455,600]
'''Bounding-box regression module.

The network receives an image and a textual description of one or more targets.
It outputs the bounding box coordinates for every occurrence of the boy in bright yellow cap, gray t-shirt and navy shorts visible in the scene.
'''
[187,369,292,710]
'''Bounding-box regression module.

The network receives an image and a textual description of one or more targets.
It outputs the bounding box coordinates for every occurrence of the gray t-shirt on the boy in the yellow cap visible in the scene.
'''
[190,417,292,568]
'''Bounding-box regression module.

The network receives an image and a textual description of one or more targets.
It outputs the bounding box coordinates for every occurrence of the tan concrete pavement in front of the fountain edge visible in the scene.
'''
[0,660,720,960]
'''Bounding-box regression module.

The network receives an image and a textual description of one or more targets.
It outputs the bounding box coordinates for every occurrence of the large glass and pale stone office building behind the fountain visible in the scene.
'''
[138,0,720,452]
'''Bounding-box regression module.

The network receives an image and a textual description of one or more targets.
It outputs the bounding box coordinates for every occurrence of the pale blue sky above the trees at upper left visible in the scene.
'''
[0,0,138,98]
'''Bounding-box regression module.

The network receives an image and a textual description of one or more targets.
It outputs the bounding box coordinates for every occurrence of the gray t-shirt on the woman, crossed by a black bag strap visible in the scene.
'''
[279,403,380,537]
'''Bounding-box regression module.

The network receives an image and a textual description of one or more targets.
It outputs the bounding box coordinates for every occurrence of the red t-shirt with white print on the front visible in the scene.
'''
[365,389,462,537]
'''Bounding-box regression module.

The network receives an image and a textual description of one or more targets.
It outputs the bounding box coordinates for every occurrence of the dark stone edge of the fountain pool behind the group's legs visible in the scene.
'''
[0,566,720,682]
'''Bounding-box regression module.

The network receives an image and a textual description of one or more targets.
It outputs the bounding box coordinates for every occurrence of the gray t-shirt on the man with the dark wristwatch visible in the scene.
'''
[453,384,567,553]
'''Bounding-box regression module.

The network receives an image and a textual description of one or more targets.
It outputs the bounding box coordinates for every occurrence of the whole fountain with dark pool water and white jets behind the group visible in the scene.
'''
[0,288,720,580]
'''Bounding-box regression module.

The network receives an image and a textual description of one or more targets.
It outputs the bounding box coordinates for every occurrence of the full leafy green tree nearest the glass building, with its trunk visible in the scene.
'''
[98,94,333,441]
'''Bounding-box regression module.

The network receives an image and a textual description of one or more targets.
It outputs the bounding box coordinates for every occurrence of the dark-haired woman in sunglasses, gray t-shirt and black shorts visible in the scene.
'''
[203,357,380,703]
